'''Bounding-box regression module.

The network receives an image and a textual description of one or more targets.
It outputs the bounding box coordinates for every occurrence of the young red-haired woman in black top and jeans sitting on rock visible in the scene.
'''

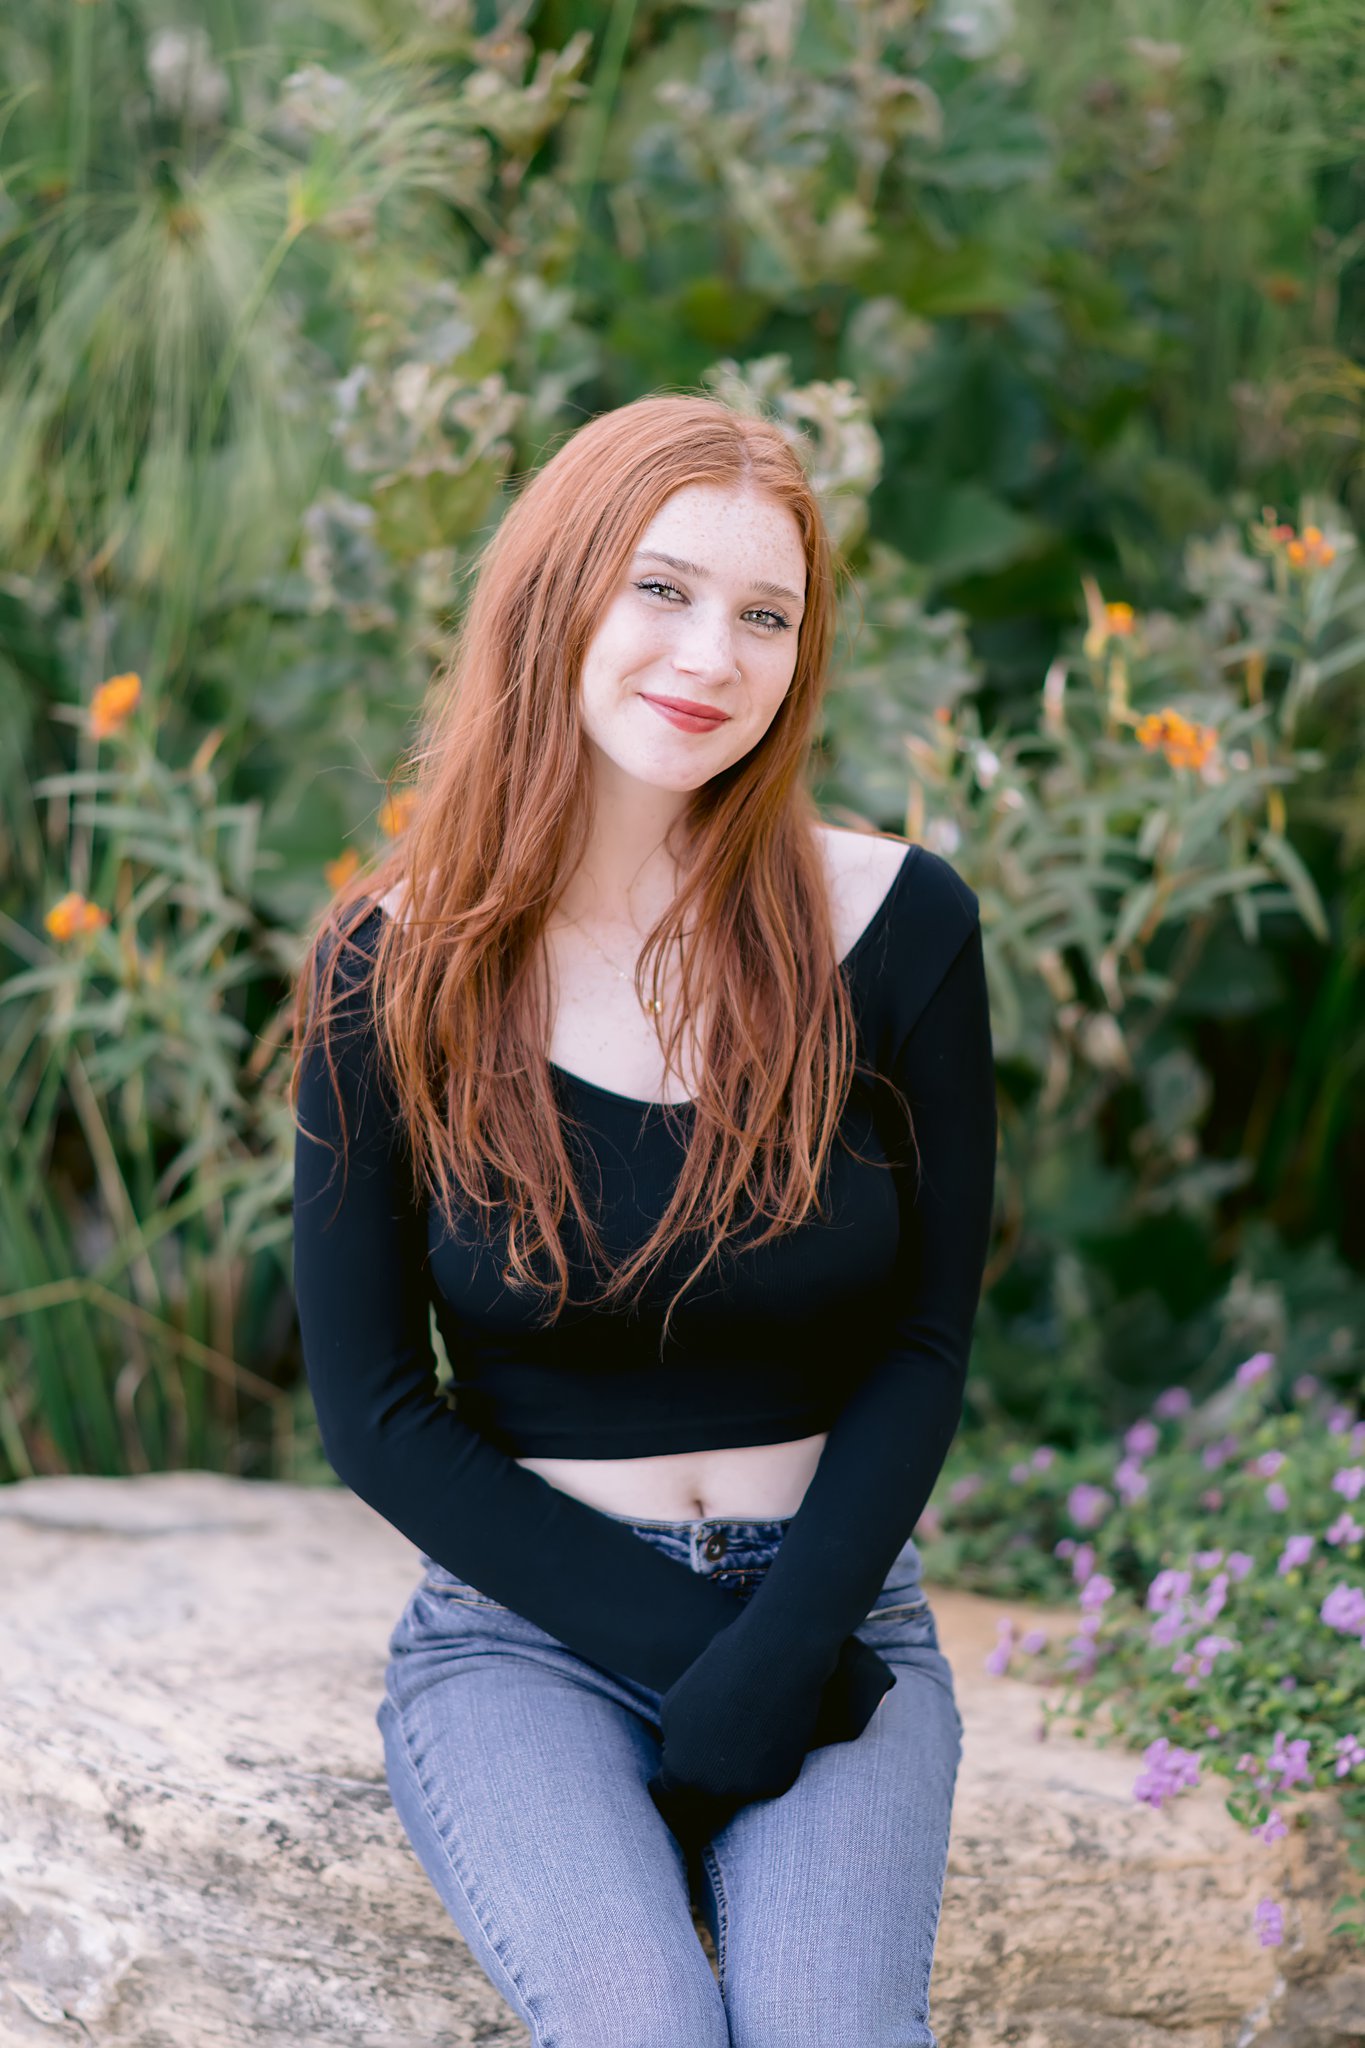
[295,395,997,2048]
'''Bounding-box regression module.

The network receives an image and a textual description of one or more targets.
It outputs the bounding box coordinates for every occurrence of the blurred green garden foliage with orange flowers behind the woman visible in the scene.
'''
[0,0,1365,1523]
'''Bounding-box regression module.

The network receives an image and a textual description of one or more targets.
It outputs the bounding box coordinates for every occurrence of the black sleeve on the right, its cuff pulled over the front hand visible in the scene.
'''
[651,905,997,1839]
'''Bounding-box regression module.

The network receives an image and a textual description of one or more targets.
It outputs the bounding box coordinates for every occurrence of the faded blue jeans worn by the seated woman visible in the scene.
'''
[377,1516,962,2048]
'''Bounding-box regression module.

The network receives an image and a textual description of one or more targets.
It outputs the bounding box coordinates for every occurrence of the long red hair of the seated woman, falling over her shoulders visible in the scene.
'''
[289,395,909,1341]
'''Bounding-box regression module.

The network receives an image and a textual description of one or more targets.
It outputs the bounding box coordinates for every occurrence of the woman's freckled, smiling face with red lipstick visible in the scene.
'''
[579,483,806,793]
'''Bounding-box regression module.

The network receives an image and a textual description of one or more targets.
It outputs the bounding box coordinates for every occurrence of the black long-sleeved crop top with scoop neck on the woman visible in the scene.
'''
[295,846,997,1843]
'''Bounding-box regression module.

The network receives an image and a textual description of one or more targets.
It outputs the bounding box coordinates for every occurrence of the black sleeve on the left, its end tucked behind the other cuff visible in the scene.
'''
[293,924,890,1712]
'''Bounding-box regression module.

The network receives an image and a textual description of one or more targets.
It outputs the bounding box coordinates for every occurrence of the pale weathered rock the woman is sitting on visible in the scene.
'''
[0,1473,1365,2048]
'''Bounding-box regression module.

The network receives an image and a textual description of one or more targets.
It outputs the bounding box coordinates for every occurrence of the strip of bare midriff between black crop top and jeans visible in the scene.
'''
[516,1432,825,1522]
